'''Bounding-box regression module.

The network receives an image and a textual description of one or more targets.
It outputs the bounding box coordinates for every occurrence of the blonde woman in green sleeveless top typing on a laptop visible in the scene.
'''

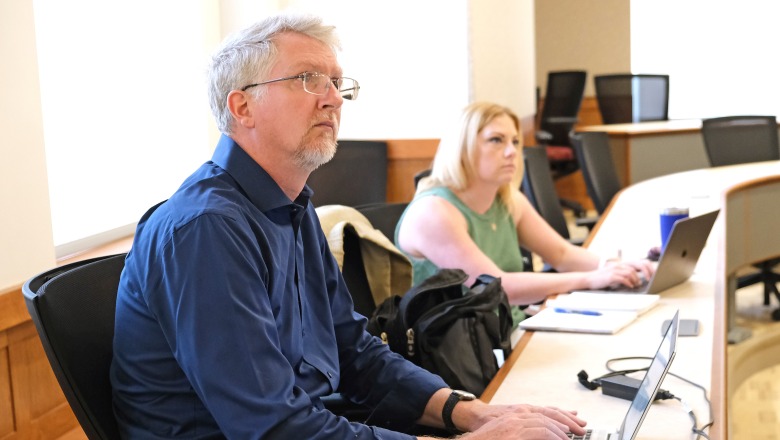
[396,102,653,316]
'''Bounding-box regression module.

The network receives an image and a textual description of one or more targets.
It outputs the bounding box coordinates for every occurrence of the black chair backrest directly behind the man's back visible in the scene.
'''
[22,254,125,439]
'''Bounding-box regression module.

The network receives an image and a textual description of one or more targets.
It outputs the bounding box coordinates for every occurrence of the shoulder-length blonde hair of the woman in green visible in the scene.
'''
[417,102,524,211]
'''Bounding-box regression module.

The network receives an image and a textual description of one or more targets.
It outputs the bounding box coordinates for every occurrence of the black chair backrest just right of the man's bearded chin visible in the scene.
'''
[307,140,388,207]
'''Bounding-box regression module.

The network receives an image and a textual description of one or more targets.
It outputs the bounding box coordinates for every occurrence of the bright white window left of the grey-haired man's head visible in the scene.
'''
[33,0,219,256]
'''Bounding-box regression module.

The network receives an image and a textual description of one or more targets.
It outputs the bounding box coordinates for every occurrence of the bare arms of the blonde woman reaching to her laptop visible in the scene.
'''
[398,192,651,304]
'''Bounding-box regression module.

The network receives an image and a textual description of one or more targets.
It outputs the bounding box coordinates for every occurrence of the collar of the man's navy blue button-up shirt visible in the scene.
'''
[211,134,312,212]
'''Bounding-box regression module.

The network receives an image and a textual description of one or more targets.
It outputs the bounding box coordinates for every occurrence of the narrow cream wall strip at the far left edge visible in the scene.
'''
[0,0,54,292]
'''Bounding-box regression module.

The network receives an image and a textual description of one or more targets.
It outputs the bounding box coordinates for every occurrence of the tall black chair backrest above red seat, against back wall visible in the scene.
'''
[539,70,587,145]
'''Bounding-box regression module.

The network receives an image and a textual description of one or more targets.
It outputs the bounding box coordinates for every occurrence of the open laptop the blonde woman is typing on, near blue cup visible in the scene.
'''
[590,210,720,294]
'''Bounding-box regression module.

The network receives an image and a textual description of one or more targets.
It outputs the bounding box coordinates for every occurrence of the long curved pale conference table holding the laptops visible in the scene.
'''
[483,161,780,440]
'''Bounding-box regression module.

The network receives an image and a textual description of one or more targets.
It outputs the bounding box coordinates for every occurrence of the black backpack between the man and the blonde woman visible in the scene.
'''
[368,269,512,396]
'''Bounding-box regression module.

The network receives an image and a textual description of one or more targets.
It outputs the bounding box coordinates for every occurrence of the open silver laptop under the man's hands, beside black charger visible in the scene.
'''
[569,310,680,440]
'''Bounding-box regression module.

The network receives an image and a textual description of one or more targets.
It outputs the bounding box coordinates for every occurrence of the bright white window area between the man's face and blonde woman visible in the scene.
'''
[222,0,470,139]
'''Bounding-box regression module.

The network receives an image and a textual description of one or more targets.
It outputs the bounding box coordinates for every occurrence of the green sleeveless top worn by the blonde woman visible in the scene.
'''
[395,187,525,325]
